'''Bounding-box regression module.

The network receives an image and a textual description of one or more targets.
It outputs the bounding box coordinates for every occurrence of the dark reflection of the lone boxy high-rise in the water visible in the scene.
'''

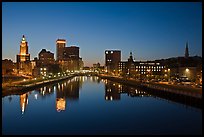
[105,81,120,100]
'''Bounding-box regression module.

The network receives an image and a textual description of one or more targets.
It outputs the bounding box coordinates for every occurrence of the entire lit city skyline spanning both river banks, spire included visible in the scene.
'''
[2,36,202,84]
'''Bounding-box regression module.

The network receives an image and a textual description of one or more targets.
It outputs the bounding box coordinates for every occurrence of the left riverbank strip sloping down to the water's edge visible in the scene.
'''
[2,75,76,97]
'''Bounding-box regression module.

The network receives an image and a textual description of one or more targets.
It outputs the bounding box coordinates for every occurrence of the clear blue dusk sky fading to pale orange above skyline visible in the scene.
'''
[2,2,202,66]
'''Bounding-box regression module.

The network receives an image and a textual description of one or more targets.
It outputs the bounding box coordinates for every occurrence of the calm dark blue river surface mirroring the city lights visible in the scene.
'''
[2,76,202,135]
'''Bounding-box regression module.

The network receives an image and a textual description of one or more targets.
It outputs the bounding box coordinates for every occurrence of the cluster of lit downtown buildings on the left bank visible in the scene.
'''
[2,35,83,77]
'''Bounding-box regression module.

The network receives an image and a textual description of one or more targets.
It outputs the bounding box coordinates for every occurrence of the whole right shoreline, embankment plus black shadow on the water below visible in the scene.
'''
[98,76,202,109]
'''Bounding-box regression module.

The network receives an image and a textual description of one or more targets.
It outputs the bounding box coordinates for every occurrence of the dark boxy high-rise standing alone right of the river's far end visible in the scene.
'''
[105,50,121,72]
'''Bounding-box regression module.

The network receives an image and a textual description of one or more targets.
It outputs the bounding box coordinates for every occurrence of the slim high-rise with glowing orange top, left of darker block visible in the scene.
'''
[56,39,66,61]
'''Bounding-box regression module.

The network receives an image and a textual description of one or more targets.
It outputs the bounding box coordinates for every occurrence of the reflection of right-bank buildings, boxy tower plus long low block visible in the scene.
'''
[103,80,150,100]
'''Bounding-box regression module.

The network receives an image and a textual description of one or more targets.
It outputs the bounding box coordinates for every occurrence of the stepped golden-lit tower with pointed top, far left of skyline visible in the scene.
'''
[17,35,30,63]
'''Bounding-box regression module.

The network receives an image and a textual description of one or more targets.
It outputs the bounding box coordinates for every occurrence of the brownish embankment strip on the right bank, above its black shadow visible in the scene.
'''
[98,75,202,99]
